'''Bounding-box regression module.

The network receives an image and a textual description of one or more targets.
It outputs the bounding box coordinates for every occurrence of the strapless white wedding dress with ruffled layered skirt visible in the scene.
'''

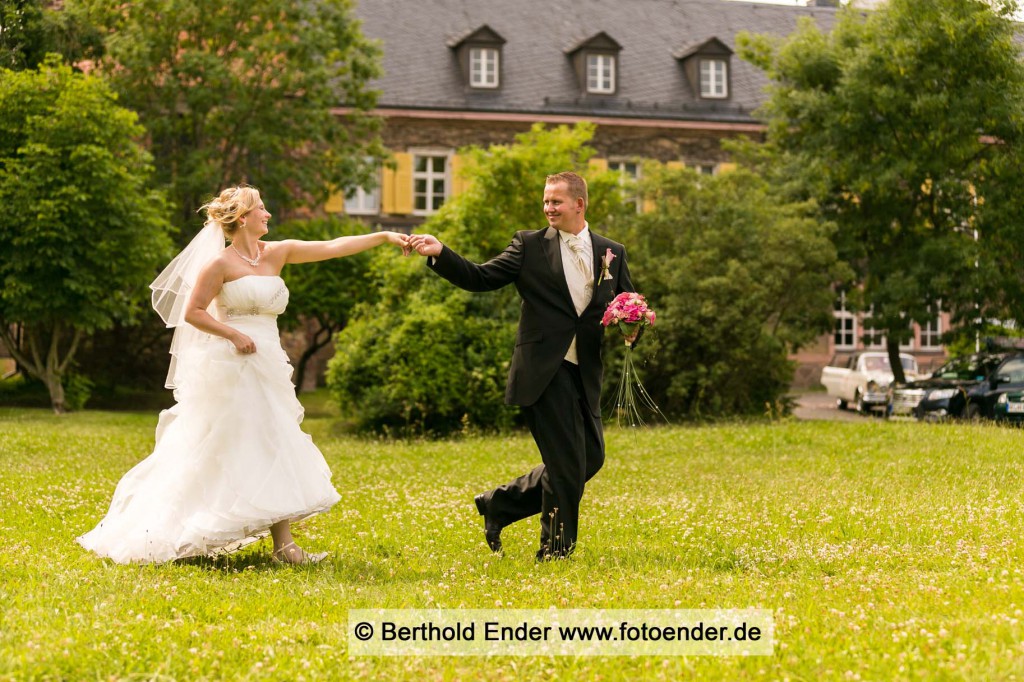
[78,274,340,563]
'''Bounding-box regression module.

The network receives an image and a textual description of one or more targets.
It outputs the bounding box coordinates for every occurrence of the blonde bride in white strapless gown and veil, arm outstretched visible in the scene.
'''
[77,186,409,563]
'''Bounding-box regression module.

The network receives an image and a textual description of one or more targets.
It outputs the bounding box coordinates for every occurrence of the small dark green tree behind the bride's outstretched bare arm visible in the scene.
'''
[270,217,376,390]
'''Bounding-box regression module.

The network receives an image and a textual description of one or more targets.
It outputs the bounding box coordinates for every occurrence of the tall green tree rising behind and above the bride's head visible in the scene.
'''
[69,0,383,233]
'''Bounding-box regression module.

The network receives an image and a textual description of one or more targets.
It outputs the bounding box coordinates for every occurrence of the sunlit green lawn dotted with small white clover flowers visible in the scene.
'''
[0,406,1024,681]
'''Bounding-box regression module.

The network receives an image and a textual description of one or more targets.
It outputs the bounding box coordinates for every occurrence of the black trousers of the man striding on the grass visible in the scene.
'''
[484,361,604,556]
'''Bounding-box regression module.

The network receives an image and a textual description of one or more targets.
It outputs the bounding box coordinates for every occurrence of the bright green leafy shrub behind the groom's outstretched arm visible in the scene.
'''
[328,123,623,433]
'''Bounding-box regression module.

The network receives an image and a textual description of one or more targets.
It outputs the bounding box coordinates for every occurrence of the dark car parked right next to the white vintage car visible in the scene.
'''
[889,352,1007,421]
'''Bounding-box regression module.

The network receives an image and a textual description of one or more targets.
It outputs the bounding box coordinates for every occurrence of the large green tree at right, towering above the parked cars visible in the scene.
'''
[739,0,1024,380]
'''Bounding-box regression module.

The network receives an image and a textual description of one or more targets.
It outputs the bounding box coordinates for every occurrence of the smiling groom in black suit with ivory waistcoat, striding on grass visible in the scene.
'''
[411,172,634,560]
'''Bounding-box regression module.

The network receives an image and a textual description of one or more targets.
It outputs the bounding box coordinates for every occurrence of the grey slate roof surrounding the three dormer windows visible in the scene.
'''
[355,0,837,122]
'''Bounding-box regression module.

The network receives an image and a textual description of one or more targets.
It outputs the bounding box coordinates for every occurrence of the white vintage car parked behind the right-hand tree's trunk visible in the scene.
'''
[821,351,918,413]
